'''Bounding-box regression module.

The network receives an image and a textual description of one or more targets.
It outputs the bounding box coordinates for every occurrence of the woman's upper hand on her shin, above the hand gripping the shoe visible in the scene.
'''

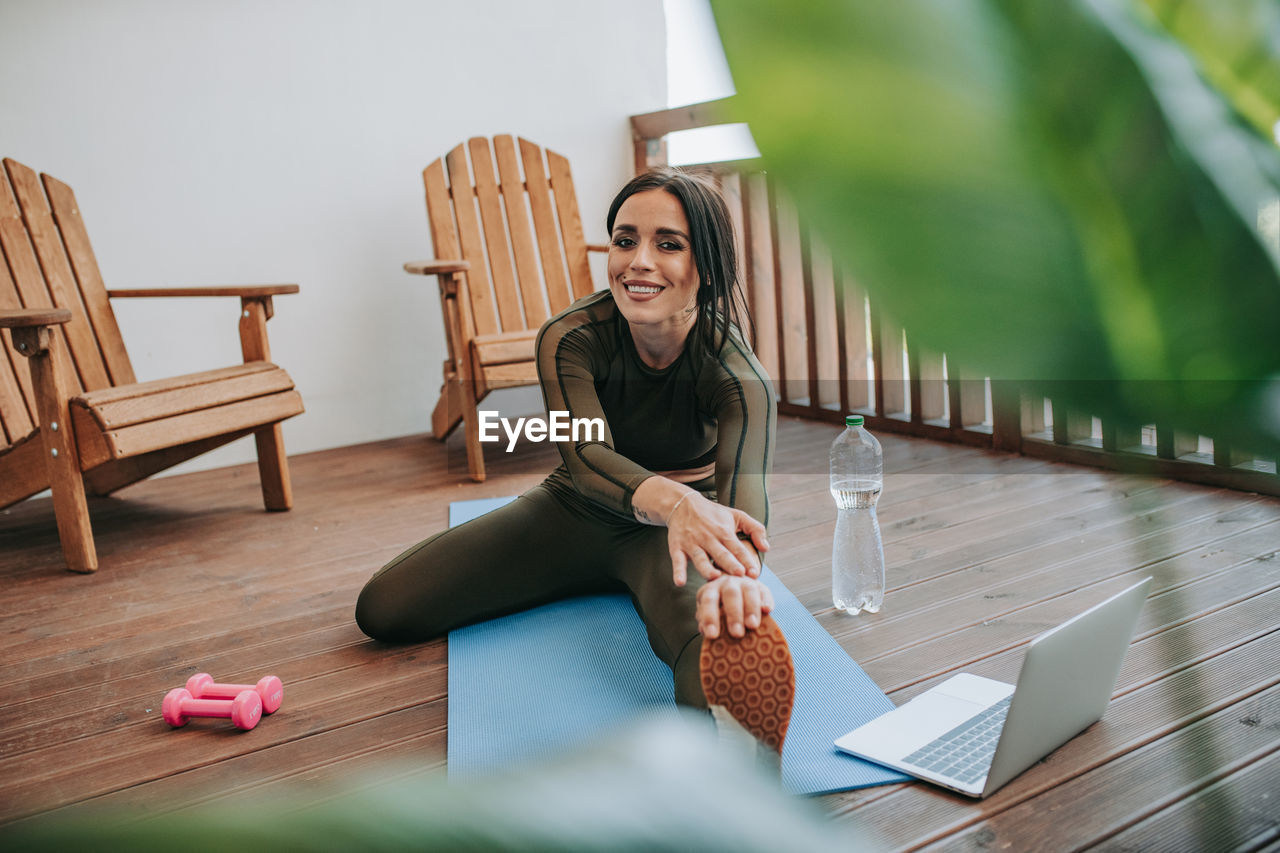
[667,491,769,587]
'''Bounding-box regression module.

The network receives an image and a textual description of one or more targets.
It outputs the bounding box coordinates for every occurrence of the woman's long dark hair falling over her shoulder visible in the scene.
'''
[605,168,755,355]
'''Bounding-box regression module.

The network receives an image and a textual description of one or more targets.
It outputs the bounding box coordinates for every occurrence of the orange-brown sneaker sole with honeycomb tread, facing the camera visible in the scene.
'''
[698,616,796,754]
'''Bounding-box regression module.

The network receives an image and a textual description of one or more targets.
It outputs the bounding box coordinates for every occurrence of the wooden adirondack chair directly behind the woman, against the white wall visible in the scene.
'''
[404,136,608,482]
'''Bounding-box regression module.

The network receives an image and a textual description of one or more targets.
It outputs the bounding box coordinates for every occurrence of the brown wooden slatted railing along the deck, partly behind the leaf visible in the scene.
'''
[631,100,1280,494]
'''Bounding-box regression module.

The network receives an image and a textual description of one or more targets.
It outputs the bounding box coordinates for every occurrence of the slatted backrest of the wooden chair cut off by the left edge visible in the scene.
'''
[0,159,134,447]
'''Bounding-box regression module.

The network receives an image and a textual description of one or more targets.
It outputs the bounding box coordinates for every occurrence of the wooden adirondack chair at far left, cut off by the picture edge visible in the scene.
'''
[0,159,302,571]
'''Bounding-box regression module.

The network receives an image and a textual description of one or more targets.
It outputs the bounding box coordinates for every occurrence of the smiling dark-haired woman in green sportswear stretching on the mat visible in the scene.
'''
[356,169,794,752]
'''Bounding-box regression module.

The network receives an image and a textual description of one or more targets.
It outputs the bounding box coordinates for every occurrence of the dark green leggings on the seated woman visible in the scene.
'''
[356,483,707,708]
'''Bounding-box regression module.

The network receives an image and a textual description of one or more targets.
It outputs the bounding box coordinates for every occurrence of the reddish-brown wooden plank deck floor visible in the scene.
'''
[0,420,1280,850]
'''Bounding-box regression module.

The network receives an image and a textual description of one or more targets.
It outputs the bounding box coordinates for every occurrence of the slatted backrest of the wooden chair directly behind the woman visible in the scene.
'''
[422,136,594,334]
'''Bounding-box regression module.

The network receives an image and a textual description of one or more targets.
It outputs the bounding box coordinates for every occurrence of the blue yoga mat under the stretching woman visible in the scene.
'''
[448,497,909,794]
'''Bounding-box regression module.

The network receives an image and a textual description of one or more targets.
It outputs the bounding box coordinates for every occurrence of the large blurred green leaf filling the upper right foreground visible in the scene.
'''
[713,0,1280,452]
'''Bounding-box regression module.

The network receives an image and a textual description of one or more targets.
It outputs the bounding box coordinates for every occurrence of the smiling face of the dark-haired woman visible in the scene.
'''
[608,190,698,336]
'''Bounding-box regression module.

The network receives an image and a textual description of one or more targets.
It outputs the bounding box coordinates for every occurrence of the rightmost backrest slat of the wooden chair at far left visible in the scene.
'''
[41,174,136,386]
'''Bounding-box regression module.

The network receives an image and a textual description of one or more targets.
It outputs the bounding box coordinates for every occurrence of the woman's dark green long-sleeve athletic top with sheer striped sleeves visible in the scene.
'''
[538,291,777,524]
